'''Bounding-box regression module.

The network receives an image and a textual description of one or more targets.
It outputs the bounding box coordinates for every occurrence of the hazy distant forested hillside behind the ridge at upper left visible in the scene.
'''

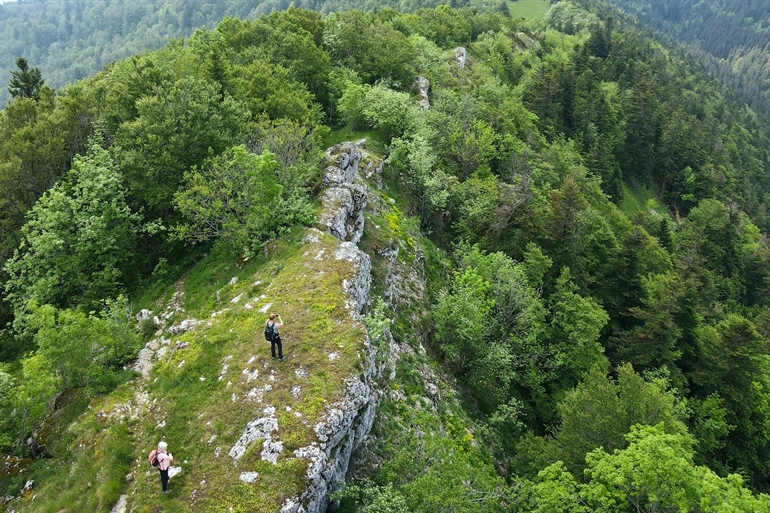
[0,0,492,105]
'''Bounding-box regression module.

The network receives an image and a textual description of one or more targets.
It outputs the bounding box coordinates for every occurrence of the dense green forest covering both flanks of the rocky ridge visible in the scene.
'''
[0,2,770,512]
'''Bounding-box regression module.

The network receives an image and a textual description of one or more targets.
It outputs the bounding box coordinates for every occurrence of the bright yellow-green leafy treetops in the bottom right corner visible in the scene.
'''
[524,425,770,513]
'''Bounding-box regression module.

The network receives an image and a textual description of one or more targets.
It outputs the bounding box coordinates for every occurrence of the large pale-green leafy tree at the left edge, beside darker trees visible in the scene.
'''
[5,138,152,327]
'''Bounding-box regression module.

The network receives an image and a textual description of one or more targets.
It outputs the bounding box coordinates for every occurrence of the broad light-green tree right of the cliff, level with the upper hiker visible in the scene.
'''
[435,246,556,428]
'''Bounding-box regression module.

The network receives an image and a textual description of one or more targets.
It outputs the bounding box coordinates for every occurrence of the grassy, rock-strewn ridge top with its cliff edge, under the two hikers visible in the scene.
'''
[13,143,374,511]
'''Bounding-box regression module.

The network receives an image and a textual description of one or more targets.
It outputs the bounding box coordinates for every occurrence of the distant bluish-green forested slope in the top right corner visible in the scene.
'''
[575,0,770,115]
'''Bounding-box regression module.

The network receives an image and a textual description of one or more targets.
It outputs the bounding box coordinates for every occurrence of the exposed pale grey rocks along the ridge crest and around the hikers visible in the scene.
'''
[105,140,382,513]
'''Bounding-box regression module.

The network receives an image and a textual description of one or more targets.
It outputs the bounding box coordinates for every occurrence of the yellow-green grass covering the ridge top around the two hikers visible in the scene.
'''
[14,226,365,512]
